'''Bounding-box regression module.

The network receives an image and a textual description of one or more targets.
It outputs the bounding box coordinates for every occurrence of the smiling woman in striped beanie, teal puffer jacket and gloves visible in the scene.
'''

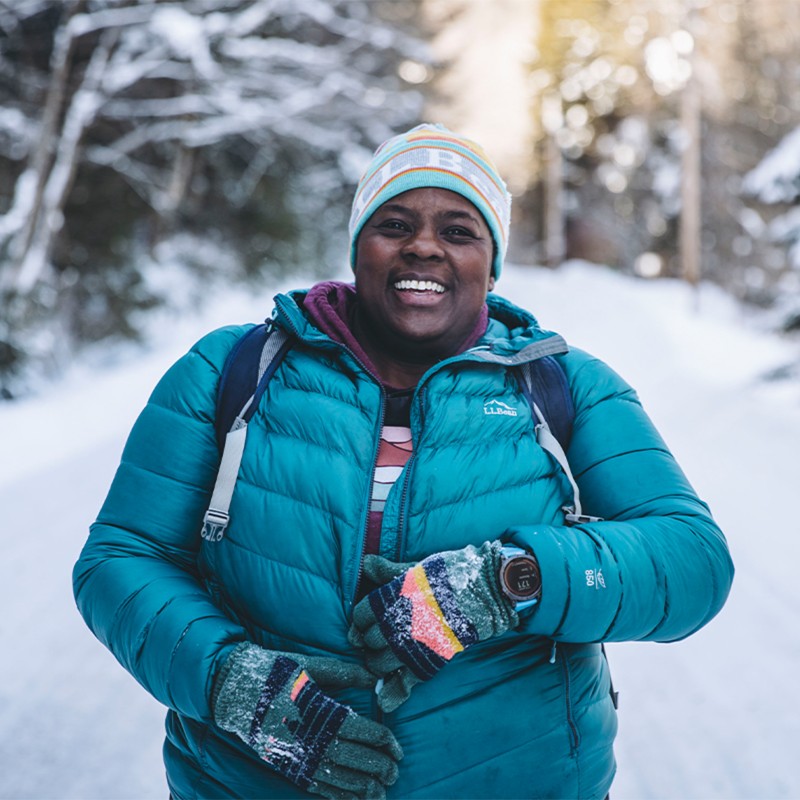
[75,125,733,798]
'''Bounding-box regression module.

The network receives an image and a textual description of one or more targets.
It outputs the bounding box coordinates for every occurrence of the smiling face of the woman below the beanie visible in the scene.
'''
[355,188,494,360]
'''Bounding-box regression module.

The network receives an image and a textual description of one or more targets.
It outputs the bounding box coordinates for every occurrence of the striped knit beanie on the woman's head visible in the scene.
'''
[350,123,511,278]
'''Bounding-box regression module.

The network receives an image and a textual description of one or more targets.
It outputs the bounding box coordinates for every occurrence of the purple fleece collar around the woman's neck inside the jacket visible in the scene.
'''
[303,281,489,389]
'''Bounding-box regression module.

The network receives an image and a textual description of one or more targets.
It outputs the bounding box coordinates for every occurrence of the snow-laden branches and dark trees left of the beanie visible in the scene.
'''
[0,0,426,394]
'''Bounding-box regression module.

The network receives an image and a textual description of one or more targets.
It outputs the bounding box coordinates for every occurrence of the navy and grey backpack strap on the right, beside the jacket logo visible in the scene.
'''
[516,356,601,525]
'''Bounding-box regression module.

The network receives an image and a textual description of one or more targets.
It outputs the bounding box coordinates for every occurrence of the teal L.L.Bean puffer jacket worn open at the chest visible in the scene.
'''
[74,292,733,798]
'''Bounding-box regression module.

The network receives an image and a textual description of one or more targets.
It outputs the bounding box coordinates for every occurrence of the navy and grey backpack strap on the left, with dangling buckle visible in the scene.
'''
[200,323,293,542]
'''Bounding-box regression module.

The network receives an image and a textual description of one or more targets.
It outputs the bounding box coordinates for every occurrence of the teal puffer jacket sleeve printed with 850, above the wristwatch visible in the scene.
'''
[510,350,733,642]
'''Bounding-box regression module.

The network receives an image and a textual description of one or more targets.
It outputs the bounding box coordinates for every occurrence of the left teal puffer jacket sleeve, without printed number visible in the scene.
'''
[73,328,252,720]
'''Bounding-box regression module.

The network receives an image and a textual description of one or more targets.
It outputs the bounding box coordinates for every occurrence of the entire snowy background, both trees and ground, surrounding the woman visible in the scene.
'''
[0,0,800,800]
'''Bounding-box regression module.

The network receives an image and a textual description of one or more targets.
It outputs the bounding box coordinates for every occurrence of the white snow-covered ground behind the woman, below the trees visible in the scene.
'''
[0,264,800,800]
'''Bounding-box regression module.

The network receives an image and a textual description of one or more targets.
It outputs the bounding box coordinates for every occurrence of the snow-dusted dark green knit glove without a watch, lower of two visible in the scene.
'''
[212,642,403,800]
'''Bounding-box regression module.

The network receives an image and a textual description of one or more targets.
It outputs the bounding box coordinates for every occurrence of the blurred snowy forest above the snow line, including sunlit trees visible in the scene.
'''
[0,0,800,399]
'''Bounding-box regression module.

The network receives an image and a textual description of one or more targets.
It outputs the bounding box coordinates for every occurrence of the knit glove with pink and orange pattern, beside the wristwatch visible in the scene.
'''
[348,542,519,711]
